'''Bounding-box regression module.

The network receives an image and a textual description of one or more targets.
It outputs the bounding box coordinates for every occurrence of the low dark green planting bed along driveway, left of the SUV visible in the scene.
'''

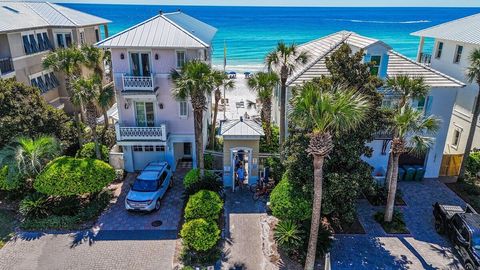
[20,191,112,230]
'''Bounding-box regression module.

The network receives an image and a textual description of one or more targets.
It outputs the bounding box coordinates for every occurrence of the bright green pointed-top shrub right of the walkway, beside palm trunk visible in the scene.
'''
[270,174,312,221]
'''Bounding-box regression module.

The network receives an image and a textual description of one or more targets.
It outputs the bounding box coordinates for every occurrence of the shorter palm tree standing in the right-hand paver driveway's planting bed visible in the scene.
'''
[384,103,440,222]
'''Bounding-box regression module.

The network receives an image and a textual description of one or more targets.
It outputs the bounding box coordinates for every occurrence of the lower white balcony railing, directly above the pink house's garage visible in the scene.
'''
[115,123,167,141]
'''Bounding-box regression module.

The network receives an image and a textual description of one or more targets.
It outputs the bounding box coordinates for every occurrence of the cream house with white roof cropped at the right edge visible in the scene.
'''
[412,14,480,176]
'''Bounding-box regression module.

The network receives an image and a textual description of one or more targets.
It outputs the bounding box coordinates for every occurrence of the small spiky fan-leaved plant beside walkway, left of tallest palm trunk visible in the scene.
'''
[273,220,305,253]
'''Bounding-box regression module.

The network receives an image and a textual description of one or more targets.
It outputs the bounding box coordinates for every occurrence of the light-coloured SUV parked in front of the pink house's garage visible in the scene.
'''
[125,162,173,212]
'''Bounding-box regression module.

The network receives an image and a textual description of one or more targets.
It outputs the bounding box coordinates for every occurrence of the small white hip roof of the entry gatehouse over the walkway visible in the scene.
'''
[220,119,265,136]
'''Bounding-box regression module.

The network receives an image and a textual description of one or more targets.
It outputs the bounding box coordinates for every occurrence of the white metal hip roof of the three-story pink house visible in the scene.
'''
[97,12,217,48]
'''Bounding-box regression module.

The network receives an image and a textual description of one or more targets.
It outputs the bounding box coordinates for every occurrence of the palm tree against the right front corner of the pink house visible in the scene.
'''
[172,60,216,176]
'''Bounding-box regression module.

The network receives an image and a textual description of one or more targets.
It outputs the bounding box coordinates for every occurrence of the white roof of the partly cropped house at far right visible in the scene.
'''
[411,13,480,45]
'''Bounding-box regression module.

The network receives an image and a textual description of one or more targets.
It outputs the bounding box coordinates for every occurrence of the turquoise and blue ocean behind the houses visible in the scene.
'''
[61,3,480,70]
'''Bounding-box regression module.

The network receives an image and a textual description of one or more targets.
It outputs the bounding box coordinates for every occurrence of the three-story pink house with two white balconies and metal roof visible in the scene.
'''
[97,12,217,172]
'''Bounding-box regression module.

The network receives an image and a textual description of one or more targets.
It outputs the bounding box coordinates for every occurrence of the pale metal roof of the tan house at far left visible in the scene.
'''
[0,1,110,33]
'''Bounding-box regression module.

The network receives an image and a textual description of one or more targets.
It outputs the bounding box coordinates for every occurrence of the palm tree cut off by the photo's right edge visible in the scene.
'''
[458,48,480,179]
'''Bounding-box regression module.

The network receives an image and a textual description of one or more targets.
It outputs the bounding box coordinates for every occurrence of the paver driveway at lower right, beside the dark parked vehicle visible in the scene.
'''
[331,180,465,269]
